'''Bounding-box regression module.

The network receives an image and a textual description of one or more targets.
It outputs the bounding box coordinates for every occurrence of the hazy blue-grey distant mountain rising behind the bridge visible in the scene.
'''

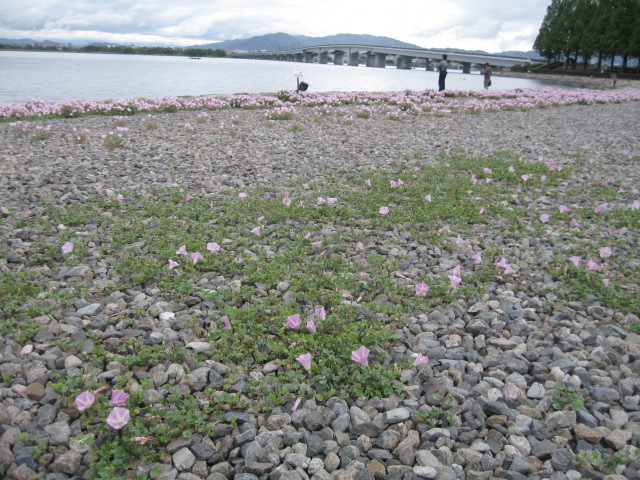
[196,33,420,51]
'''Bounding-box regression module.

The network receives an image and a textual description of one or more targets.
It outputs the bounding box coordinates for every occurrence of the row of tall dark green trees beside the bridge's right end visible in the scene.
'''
[533,0,640,70]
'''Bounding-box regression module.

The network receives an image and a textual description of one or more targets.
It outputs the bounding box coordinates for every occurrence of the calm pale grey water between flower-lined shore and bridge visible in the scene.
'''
[0,51,566,103]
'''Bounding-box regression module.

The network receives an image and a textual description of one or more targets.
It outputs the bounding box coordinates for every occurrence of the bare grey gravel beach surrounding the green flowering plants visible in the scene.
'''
[0,93,640,480]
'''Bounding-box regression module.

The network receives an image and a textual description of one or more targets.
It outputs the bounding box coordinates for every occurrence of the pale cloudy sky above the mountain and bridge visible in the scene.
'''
[0,0,551,52]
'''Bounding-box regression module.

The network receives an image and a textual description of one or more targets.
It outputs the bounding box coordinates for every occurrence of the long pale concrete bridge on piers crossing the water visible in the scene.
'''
[233,44,542,73]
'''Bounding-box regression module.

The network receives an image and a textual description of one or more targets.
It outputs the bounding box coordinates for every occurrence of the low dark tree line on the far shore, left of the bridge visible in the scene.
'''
[0,44,227,57]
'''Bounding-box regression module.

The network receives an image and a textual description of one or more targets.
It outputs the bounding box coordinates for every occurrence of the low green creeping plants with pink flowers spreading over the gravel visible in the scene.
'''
[0,152,640,478]
